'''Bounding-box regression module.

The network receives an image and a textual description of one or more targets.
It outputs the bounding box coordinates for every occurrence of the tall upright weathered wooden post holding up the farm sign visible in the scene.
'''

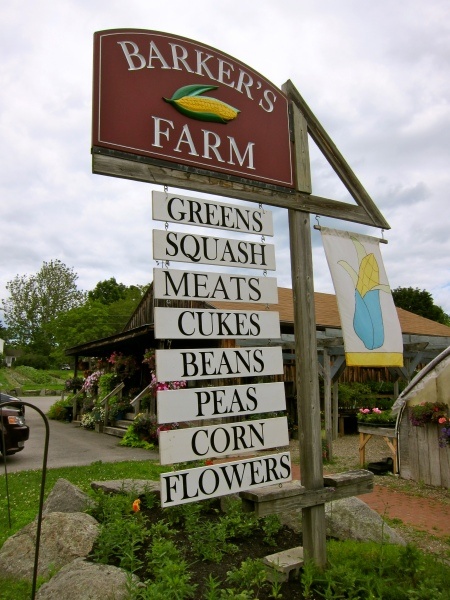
[289,96,327,567]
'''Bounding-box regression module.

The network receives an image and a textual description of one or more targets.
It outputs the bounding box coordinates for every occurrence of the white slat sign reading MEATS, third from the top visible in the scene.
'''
[153,269,278,304]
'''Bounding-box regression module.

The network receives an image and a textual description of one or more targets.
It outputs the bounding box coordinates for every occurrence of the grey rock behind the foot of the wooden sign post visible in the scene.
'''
[280,497,405,546]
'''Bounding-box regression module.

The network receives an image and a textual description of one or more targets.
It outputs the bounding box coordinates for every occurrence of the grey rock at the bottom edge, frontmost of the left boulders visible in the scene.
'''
[36,558,138,600]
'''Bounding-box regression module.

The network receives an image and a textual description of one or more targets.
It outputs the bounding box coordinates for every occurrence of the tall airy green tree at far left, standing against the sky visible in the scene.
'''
[2,259,85,356]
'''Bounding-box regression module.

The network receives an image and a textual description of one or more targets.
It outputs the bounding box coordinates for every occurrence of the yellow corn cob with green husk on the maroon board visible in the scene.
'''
[164,85,240,123]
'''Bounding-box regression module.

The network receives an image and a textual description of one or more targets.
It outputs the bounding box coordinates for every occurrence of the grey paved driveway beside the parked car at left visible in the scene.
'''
[0,396,158,474]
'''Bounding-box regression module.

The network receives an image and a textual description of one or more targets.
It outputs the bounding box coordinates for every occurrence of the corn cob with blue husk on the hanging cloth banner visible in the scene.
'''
[338,238,391,350]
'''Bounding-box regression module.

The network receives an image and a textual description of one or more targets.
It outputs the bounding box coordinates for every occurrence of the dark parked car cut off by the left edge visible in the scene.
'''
[0,394,30,455]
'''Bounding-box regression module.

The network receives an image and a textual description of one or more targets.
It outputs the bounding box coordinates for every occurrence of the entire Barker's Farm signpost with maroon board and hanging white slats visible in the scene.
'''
[92,29,389,566]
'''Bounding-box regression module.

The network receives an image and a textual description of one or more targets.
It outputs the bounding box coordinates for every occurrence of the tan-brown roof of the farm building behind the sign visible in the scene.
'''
[209,288,450,337]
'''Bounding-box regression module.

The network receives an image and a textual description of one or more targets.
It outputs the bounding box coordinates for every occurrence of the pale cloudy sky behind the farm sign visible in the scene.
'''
[0,0,450,318]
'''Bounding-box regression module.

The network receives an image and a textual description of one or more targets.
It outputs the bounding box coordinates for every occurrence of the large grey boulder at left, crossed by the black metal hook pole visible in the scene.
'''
[0,512,99,579]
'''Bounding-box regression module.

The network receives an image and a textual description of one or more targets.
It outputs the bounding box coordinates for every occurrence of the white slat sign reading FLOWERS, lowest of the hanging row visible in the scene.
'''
[160,452,292,508]
